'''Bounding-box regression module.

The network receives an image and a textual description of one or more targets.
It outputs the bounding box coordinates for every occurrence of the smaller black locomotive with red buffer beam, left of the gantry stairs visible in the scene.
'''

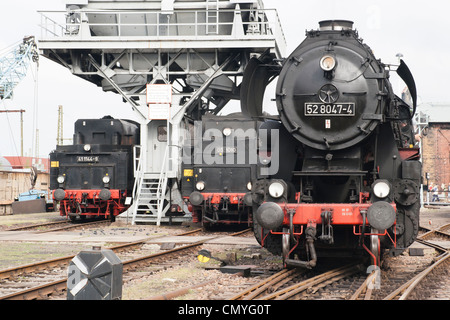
[50,116,140,221]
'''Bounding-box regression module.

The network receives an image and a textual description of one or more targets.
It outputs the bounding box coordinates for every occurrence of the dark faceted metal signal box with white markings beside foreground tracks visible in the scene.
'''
[67,247,123,300]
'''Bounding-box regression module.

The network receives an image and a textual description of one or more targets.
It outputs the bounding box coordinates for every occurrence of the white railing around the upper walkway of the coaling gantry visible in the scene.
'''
[38,9,286,43]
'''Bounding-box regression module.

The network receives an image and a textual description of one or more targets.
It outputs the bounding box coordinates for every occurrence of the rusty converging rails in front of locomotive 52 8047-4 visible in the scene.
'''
[231,224,450,300]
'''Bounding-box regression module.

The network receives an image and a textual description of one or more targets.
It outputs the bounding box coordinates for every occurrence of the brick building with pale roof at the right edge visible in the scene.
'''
[419,104,450,191]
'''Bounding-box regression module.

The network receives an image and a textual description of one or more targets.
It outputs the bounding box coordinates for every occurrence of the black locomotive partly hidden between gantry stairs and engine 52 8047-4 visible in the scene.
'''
[182,114,260,229]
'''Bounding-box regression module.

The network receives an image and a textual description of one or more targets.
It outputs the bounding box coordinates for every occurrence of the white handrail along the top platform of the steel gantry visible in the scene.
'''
[38,9,286,47]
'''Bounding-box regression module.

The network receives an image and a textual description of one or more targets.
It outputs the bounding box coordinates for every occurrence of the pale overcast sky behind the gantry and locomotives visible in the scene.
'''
[0,0,450,157]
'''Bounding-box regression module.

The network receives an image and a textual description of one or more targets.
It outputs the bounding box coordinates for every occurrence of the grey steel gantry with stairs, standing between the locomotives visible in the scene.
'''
[39,0,286,224]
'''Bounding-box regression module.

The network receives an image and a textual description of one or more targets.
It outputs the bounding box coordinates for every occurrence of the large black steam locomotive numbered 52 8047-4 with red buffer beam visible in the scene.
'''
[241,20,421,268]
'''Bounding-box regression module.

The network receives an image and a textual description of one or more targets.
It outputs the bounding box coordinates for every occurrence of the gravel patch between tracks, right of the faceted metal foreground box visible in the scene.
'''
[122,244,281,300]
